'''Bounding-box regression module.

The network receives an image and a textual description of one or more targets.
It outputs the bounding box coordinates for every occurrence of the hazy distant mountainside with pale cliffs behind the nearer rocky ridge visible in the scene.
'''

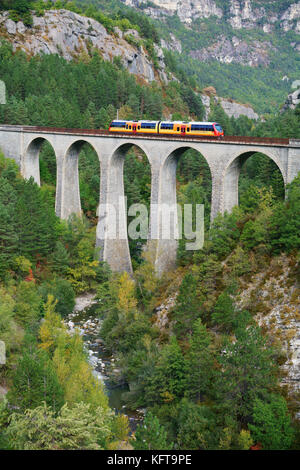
[75,0,300,114]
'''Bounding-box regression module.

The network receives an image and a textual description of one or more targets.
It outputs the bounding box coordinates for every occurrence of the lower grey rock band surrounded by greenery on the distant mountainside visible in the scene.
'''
[190,36,274,67]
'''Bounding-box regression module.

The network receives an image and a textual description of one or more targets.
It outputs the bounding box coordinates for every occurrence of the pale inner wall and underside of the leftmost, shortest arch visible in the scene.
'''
[22,137,57,186]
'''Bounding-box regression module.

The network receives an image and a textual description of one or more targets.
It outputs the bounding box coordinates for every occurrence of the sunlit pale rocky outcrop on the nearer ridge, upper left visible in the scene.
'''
[0,10,162,82]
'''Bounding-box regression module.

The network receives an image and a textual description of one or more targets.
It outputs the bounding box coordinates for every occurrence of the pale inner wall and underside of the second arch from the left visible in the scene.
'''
[61,139,101,219]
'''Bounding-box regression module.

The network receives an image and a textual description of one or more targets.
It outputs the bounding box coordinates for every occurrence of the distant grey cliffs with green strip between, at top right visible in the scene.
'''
[122,0,300,78]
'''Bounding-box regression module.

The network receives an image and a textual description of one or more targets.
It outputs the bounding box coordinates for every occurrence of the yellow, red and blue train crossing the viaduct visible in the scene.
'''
[109,120,224,137]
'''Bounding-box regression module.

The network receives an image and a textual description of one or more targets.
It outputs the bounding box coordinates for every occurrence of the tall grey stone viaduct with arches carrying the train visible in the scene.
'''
[0,125,300,273]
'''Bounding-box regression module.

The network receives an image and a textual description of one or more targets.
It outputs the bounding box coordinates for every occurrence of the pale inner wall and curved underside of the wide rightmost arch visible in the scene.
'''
[222,147,286,212]
